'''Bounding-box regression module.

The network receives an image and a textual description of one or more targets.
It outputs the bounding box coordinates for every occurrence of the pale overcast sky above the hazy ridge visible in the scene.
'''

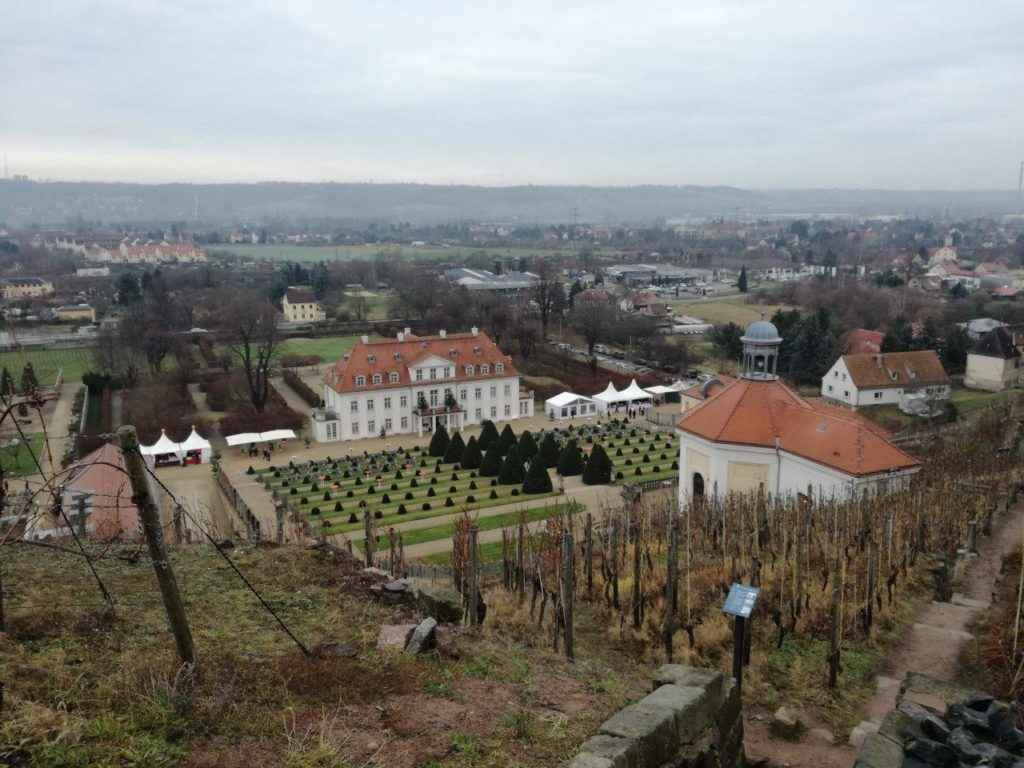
[0,0,1024,189]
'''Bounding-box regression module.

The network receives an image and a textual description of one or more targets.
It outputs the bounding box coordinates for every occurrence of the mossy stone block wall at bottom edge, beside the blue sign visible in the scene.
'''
[568,665,743,768]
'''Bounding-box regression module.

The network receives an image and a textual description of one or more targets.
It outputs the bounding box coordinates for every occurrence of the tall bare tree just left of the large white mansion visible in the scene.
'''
[214,291,281,413]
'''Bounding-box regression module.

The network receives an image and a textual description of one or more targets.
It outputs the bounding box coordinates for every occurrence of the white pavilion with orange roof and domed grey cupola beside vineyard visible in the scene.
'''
[677,321,920,504]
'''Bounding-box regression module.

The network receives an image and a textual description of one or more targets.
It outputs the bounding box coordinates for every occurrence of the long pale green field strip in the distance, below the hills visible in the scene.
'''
[208,244,593,262]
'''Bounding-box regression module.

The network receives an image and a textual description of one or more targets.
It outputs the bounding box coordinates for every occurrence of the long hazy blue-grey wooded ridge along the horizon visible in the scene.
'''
[0,180,1019,226]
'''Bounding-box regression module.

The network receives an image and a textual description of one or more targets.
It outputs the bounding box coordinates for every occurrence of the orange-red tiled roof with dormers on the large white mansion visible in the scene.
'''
[324,332,518,393]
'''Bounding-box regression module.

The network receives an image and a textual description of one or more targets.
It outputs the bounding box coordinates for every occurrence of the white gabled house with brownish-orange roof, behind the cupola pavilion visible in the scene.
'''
[821,349,950,412]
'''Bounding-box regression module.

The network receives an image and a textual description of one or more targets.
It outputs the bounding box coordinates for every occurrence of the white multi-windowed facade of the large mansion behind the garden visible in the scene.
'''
[313,368,534,442]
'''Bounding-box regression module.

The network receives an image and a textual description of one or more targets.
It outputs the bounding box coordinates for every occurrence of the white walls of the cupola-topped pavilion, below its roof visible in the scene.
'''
[678,430,914,505]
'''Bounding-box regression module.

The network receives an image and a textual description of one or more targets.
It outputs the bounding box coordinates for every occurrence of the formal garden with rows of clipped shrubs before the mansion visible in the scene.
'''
[248,420,678,544]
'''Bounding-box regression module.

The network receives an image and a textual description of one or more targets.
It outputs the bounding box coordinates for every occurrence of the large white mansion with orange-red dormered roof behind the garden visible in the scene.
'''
[312,328,534,442]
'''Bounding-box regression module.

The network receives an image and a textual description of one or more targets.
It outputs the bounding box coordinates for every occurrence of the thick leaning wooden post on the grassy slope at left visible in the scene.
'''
[118,425,196,670]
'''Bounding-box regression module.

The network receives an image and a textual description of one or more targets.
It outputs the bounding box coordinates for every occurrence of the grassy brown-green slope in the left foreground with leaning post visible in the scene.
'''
[0,547,648,768]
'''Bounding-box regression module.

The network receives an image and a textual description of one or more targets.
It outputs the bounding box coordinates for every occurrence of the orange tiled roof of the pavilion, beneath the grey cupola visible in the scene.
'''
[679,379,919,476]
